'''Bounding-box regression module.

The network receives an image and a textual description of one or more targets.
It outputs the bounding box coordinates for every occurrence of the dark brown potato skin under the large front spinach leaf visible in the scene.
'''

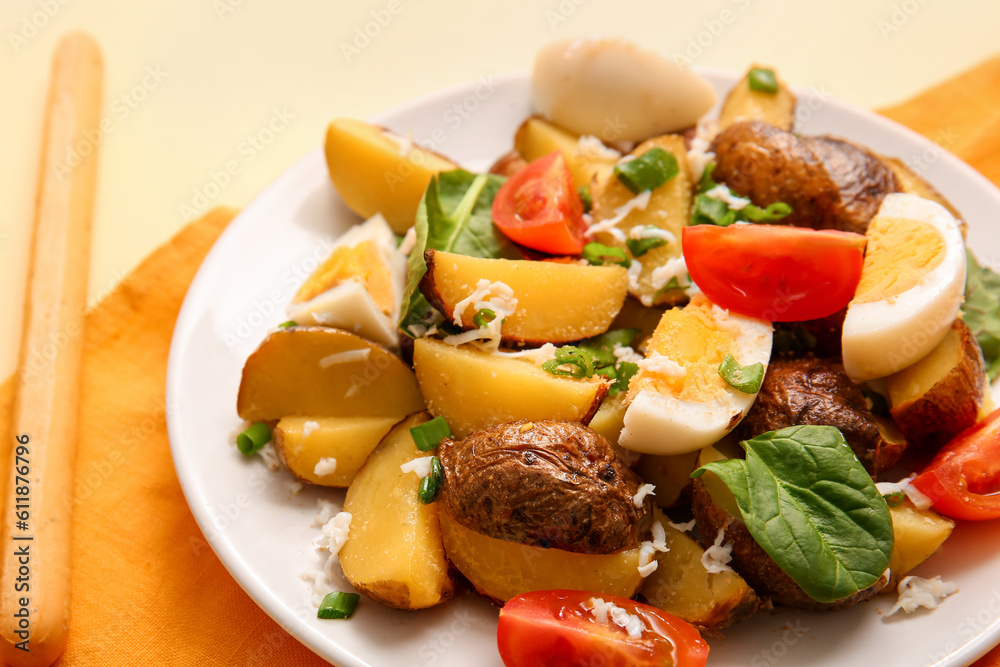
[692,479,888,611]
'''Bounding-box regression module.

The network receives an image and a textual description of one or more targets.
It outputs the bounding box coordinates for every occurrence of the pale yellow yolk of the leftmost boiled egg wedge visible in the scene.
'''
[294,240,393,315]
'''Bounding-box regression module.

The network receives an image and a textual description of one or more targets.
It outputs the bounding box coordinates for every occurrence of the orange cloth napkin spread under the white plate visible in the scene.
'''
[0,57,1000,667]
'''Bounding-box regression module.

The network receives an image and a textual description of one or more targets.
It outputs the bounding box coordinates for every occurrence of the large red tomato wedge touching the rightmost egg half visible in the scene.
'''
[681,224,865,322]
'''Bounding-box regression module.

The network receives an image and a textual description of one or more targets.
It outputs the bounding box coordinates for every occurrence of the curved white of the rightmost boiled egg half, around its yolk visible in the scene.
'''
[842,194,966,380]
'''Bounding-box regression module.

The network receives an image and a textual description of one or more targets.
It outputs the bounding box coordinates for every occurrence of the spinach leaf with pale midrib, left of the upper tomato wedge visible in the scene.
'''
[399,169,523,338]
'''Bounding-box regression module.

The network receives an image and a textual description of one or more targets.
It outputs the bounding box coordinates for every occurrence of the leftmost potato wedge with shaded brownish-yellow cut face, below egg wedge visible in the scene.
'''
[236,327,424,421]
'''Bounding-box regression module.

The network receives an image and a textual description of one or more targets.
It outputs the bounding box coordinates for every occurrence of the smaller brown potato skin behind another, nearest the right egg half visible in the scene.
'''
[802,136,900,234]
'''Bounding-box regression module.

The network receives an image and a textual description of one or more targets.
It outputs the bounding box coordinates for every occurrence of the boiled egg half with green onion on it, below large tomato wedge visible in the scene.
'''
[618,294,772,454]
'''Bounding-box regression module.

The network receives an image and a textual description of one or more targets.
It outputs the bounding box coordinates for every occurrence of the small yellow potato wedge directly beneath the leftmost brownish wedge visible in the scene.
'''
[274,415,406,487]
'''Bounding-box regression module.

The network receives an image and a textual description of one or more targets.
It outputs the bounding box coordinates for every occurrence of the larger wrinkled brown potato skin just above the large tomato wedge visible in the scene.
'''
[712,120,840,229]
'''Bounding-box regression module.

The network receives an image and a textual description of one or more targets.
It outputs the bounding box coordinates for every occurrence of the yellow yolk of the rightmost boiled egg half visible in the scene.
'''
[854,217,945,303]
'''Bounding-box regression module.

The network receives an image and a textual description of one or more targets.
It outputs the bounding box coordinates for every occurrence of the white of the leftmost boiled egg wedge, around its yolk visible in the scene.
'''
[287,214,406,349]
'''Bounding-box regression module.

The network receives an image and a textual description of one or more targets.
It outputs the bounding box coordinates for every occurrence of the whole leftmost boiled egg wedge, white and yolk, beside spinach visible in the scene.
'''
[287,215,406,348]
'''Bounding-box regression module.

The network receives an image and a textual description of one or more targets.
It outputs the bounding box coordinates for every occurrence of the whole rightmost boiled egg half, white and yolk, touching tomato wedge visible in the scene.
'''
[842,194,965,380]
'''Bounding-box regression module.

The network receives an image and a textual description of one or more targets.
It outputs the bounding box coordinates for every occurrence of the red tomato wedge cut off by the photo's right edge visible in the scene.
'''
[912,410,1000,521]
